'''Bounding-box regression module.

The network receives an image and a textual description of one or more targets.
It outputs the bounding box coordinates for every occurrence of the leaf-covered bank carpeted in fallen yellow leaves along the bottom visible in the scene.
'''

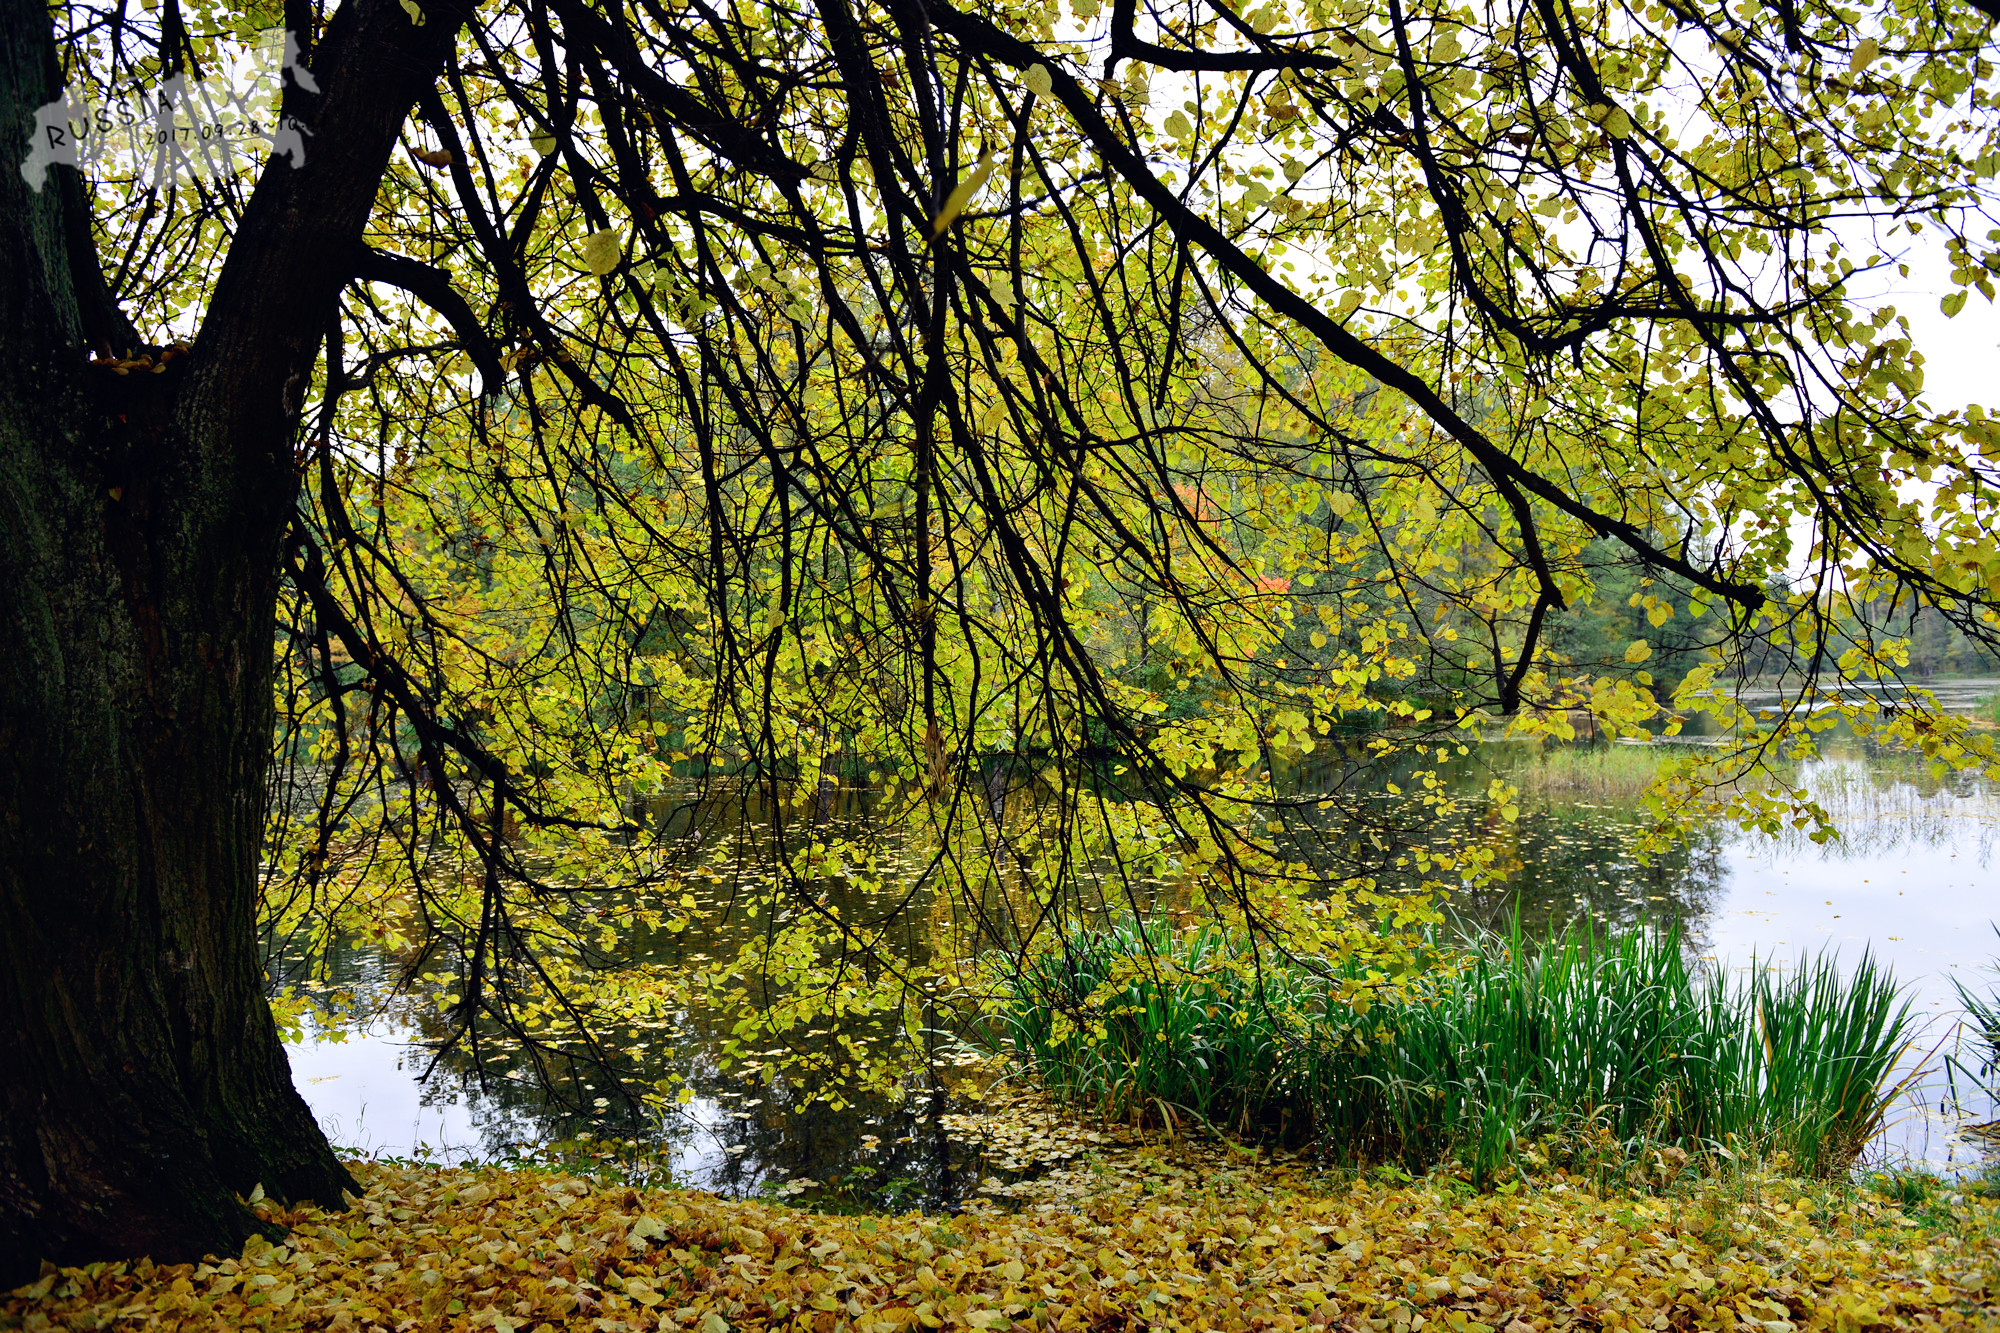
[0,1145,2000,1333]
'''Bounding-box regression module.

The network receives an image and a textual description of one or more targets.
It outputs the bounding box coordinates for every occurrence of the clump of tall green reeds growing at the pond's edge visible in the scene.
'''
[1004,923,1912,1185]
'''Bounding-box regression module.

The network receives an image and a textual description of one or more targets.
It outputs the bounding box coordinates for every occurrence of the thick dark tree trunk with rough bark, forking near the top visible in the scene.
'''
[0,0,464,1287]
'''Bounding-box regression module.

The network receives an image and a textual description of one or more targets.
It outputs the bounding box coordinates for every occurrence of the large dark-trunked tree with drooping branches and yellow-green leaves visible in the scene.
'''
[0,0,2000,1273]
